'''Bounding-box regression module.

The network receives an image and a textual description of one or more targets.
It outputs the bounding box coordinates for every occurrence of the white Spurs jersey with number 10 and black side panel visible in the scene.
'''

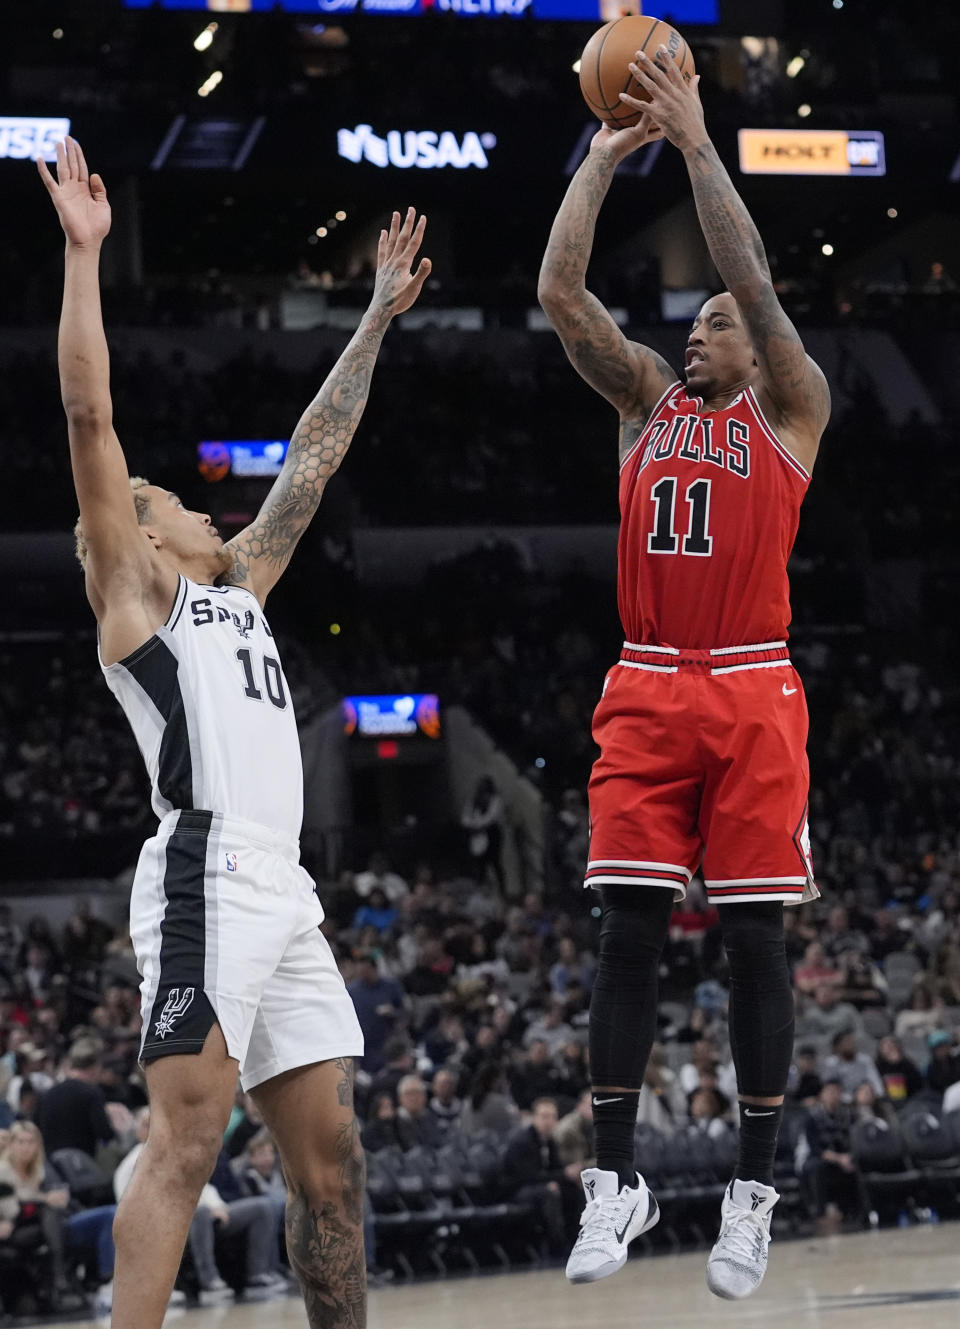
[101,577,303,840]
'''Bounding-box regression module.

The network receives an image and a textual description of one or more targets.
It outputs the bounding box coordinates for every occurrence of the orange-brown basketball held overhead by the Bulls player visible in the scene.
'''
[580,15,695,129]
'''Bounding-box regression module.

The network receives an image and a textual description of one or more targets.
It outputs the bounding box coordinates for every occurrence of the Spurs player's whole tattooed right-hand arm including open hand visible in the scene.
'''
[221,207,431,603]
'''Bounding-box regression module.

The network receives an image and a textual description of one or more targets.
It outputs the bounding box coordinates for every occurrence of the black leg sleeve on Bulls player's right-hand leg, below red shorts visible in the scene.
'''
[719,900,794,1098]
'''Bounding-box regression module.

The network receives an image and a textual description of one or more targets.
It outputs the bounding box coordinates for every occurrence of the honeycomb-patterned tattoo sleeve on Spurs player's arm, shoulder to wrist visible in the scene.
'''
[221,311,390,586]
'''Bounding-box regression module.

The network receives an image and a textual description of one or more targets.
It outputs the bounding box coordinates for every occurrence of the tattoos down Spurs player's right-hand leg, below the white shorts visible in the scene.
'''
[286,1058,367,1329]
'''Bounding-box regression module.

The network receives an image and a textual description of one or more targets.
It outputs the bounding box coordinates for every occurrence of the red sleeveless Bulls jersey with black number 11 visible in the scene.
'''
[617,383,810,650]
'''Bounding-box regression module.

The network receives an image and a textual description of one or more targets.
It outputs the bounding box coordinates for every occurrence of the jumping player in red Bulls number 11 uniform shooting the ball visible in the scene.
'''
[540,51,830,1297]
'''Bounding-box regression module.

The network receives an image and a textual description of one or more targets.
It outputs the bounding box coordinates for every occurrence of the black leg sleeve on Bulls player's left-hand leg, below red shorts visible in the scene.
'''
[590,886,673,1090]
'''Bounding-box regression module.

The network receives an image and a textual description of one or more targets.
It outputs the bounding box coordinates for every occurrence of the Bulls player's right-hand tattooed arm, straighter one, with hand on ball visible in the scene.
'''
[621,48,830,460]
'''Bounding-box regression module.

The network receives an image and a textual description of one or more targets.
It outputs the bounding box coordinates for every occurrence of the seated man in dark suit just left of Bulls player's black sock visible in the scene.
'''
[503,1098,582,1256]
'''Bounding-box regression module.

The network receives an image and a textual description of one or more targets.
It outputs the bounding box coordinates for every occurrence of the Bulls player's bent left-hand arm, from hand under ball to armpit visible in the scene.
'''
[537,121,677,456]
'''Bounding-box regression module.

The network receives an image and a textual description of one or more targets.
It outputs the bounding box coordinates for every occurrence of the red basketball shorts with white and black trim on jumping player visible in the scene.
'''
[585,642,819,904]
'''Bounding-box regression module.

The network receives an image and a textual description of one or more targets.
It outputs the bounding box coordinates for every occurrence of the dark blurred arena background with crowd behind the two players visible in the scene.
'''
[0,0,960,1314]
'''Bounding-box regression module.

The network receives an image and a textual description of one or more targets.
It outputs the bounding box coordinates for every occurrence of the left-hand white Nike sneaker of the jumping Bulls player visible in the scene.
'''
[566,1167,660,1282]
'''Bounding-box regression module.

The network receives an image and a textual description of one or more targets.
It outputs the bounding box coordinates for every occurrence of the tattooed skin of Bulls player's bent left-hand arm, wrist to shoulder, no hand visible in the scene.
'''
[540,153,674,428]
